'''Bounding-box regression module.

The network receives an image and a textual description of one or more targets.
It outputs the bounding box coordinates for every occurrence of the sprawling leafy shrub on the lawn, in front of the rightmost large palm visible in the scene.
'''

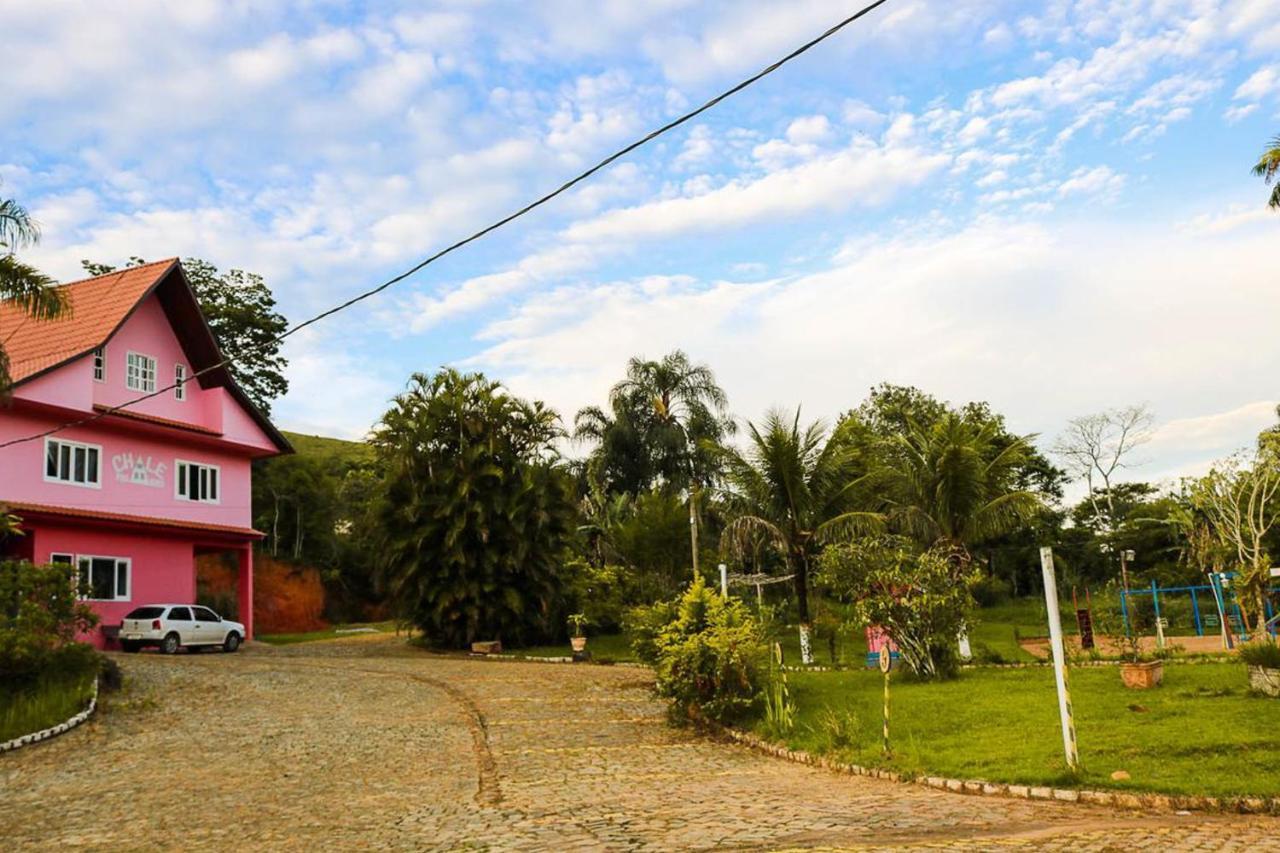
[820,537,978,679]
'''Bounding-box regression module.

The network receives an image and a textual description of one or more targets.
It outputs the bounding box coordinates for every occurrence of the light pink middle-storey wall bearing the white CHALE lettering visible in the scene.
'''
[0,410,252,528]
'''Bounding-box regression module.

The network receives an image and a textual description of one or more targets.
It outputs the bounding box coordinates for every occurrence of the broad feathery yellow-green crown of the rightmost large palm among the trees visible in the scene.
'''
[877,411,1041,561]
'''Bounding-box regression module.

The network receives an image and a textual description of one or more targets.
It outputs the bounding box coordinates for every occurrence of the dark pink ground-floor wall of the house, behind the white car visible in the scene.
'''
[29,524,196,646]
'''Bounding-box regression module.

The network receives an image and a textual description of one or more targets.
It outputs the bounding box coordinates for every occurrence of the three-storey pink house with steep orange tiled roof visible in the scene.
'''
[0,260,292,646]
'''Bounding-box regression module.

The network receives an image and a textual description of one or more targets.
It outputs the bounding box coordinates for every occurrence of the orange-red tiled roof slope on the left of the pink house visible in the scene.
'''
[0,257,178,384]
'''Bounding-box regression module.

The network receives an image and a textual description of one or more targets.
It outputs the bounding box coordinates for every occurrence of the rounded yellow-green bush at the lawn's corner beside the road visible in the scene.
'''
[654,578,765,722]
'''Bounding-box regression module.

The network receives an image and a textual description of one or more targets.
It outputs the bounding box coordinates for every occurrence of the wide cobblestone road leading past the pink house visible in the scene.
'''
[0,638,1280,850]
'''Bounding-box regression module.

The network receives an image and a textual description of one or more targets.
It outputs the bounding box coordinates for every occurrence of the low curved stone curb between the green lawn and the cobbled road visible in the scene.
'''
[703,721,1280,815]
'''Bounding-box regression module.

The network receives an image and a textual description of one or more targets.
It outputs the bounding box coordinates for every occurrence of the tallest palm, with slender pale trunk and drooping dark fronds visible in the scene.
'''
[573,350,735,576]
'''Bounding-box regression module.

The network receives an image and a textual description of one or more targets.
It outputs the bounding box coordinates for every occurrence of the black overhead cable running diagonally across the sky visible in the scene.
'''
[0,0,888,450]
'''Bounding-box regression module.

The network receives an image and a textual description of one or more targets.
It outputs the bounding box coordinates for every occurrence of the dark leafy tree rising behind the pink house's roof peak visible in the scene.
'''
[81,257,289,415]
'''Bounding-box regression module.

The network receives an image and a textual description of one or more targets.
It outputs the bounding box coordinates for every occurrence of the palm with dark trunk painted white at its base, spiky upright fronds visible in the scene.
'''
[723,409,882,663]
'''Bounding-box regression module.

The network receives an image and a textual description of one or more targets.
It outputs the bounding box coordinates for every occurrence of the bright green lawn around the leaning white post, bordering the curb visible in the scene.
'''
[762,663,1280,795]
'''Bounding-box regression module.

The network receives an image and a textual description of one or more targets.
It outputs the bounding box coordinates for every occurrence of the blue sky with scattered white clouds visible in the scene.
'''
[0,0,1280,489]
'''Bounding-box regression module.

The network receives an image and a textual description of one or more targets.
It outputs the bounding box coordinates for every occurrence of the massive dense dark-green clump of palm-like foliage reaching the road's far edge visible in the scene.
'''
[372,369,575,647]
